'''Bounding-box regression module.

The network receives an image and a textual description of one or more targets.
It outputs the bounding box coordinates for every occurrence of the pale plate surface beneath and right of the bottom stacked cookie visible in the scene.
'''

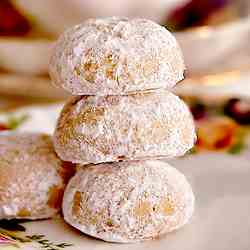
[0,153,250,250]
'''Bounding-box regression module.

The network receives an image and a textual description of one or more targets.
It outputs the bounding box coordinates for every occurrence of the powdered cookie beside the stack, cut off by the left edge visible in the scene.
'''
[0,132,74,219]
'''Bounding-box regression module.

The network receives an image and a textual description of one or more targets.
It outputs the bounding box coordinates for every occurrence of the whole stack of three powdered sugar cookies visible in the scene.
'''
[50,17,196,242]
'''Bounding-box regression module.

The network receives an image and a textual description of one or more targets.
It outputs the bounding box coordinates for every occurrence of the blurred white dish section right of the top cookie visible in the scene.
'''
[176,17,250,74]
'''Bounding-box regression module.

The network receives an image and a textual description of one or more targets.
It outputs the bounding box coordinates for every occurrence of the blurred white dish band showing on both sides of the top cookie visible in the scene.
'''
[0,17,250,74]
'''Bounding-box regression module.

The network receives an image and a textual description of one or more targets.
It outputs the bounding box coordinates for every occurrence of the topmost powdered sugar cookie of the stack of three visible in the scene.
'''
[50,17,185,95]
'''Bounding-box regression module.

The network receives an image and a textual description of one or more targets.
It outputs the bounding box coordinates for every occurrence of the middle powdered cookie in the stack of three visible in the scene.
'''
[53,91,196,164]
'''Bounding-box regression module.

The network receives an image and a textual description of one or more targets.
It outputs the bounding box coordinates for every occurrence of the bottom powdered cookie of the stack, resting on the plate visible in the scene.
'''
[63,161,194,243]
